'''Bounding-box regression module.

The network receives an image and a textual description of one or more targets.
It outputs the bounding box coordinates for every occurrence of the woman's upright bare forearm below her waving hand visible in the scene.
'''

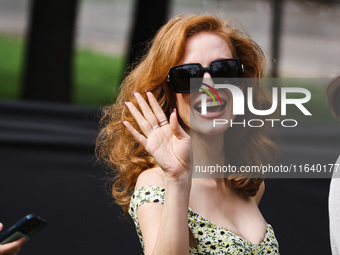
[152,175,191,255]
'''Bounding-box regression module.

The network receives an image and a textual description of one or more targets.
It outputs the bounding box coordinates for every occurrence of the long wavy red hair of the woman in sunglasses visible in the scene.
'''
[96,15,276,212]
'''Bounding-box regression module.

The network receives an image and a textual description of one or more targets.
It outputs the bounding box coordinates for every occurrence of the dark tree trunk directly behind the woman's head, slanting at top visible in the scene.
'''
[123,0,170,78]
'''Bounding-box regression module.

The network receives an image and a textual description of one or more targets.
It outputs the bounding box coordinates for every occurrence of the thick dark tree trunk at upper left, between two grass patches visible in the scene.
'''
[22,0,78,102]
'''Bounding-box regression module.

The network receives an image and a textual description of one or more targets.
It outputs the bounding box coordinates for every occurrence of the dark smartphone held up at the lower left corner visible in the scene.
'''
[0,214,47,244]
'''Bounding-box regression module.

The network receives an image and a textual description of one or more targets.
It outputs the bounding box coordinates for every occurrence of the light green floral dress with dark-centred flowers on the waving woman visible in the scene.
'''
[129,186,279,255]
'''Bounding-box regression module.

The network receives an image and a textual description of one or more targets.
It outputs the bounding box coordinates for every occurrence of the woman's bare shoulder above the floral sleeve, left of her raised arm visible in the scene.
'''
[135,167,165,190]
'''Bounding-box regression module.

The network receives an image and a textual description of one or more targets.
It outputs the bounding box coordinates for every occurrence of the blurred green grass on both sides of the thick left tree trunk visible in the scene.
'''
[0,36,124,106]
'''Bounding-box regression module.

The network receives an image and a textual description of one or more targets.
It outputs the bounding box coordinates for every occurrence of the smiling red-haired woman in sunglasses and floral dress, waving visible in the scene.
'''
[96,15,279,255]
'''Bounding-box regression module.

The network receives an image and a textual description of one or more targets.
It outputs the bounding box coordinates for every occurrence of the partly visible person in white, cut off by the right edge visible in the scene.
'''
[326,76,340,255]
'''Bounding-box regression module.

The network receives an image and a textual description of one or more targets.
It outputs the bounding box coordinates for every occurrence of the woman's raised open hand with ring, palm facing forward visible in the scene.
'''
[122,92,190,178]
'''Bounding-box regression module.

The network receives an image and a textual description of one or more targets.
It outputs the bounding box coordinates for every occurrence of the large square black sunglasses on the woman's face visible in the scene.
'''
[166,58,243,93]
